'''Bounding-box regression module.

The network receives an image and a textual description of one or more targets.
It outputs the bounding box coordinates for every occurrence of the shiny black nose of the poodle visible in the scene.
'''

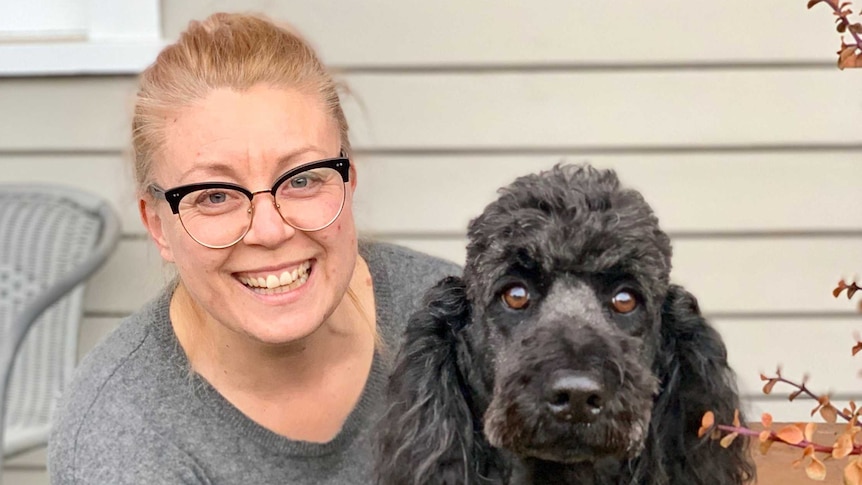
[545,372,605,423]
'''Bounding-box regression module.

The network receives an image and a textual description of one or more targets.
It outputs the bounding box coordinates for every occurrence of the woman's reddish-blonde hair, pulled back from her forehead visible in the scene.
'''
[132,13,351,189]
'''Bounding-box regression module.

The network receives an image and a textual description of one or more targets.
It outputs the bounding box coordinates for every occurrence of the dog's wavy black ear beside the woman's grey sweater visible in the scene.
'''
[376,277,500,485]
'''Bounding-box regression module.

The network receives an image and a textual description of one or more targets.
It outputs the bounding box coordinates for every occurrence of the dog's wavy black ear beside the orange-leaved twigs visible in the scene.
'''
[649,285,755,485]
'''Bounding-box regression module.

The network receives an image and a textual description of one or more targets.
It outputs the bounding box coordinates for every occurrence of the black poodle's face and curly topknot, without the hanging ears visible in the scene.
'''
[464,165,671,463]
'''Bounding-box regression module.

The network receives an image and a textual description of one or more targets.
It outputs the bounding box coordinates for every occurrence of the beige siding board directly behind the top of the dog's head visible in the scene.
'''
[0,151,862,235]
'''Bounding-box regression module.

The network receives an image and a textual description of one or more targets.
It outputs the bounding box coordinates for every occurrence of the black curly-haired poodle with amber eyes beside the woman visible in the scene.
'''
[376,165,754,485]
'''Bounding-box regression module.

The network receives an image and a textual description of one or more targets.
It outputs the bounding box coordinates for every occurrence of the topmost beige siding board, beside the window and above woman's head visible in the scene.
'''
[162,0,839,68]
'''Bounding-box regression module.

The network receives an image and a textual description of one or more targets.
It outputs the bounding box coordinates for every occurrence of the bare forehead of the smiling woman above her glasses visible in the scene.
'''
[153,85,340,183]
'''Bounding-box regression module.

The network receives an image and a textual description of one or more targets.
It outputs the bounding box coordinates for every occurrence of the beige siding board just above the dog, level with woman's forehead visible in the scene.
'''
[5,68,862,152]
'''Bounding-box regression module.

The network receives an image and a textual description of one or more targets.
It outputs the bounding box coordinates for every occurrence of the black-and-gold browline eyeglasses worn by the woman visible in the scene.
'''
[148,152,350,249]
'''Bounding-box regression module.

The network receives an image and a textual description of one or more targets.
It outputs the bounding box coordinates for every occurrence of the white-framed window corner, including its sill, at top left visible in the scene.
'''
[0,0,163,76]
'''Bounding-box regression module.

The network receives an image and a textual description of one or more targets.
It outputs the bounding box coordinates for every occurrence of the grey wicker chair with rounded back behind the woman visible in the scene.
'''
[0,184,120,473]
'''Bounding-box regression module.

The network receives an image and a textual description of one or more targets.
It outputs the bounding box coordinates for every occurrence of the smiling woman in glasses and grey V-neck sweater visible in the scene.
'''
[48,14,458,484]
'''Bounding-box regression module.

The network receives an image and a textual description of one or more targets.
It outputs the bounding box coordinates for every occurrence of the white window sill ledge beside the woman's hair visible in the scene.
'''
[0,39,165,76]
